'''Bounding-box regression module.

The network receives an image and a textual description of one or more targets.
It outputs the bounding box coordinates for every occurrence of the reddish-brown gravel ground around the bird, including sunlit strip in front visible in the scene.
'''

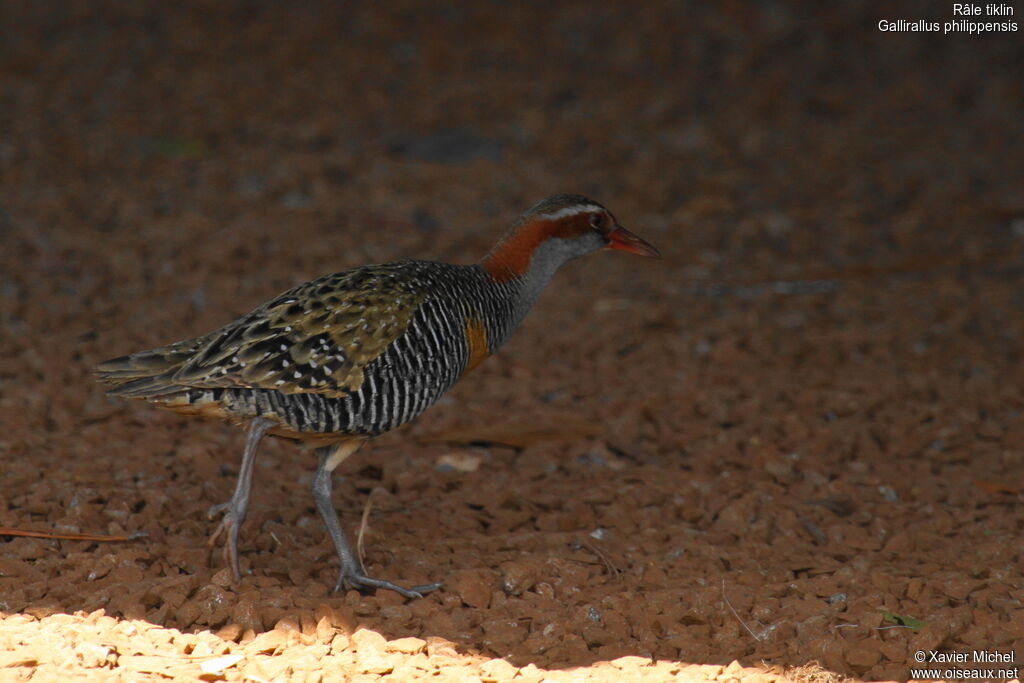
[0,2,1024,681]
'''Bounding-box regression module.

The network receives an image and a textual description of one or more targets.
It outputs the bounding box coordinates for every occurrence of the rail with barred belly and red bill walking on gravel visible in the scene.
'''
[95,195,659,598]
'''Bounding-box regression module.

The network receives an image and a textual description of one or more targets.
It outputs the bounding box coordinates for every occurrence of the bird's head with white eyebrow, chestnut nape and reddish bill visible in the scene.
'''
[482,195,659,280]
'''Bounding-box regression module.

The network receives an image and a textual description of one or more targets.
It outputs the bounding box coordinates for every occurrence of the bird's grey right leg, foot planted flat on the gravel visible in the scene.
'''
[312,439,440,598]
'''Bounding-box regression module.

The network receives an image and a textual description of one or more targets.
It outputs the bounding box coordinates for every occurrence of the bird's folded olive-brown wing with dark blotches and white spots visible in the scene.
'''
[100,263,427,396]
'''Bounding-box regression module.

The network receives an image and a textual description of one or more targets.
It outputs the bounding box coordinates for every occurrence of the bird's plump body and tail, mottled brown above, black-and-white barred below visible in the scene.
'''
[97,261,513,434]
